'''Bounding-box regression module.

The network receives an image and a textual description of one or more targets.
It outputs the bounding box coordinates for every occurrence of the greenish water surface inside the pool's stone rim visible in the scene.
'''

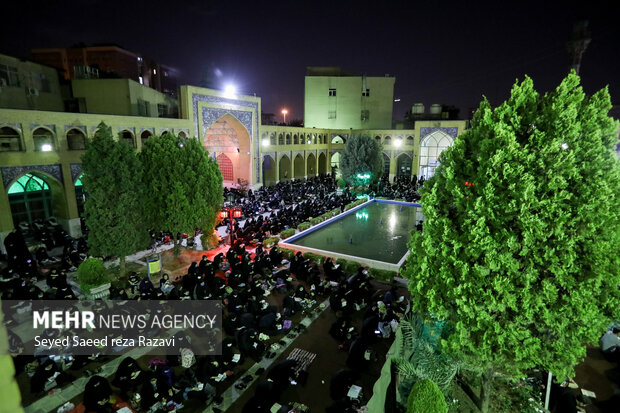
[291,202,422,264]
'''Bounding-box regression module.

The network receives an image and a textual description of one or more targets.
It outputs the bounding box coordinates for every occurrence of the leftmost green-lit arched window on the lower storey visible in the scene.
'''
[9,173,54,226]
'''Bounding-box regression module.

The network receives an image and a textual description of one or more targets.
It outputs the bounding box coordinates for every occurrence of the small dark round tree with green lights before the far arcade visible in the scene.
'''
[340,134,383,186]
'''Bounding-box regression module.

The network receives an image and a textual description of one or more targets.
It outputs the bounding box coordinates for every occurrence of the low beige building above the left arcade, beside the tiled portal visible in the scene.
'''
[71,79,178,118]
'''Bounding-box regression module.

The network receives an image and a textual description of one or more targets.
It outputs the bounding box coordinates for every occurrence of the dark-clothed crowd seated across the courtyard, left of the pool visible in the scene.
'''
[0,173,416,412]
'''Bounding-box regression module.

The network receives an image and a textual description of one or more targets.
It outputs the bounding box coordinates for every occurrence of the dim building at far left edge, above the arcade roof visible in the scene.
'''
[0,55,64,111]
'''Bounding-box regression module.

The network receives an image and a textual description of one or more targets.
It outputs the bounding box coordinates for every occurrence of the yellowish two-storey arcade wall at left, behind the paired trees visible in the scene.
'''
[0,109,192,246]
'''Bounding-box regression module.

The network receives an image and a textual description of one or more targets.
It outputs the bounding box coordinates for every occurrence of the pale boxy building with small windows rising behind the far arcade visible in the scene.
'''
[304,76,395,129]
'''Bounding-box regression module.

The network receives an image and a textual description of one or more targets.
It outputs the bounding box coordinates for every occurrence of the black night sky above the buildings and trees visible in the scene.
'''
[0,0,620,120]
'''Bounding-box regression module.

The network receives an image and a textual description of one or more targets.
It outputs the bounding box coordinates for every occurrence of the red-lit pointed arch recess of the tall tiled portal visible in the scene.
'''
[204,113,252,185]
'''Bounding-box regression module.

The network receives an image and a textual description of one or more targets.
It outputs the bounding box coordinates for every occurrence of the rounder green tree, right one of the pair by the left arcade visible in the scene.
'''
[140,133,223,256]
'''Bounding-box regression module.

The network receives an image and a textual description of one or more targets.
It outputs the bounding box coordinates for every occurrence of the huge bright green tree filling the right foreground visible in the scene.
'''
[404,73,620,412]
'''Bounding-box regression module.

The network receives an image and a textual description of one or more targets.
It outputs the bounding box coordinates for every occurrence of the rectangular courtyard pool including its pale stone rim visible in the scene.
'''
[281,200,422,270]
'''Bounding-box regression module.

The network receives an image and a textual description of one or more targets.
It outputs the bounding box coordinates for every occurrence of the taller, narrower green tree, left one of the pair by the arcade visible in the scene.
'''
[82,122,149,276]
